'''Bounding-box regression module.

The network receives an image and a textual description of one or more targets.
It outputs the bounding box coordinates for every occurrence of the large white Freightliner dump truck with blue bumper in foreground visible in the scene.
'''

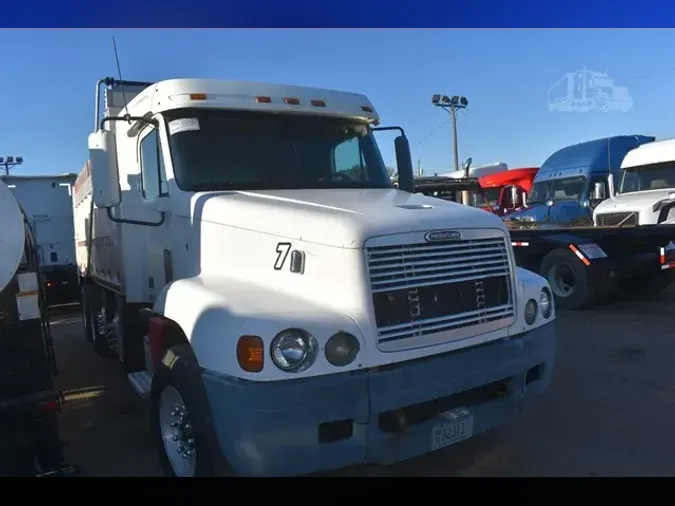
[74,78,555,476]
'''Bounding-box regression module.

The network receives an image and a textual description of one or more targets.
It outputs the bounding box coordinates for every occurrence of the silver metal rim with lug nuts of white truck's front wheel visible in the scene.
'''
[159,386,197,477]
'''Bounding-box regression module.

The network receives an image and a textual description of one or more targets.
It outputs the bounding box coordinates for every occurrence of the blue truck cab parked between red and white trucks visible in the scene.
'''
[508,135,654,225]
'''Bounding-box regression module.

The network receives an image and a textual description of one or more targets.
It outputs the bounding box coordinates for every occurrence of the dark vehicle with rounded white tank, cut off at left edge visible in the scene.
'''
[0,177,75,476]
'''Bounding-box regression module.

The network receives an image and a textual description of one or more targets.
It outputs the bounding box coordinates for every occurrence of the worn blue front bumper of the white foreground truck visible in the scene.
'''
[203,323,555,476]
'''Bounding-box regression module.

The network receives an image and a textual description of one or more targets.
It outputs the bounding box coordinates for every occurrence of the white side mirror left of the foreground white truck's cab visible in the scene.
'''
[88,130,122,208]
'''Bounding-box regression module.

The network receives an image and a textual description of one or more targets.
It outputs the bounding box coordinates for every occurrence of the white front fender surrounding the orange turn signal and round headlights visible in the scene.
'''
[153,276,366,381]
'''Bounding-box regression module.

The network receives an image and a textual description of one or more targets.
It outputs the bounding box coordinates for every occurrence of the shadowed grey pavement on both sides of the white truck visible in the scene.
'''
[52,289,675,476]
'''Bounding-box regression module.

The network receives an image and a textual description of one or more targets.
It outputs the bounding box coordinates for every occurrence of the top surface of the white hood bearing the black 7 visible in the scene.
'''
[191,188,506,248]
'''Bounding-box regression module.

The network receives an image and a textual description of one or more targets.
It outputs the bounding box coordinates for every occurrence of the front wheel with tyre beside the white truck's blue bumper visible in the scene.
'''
[151,344,230,478]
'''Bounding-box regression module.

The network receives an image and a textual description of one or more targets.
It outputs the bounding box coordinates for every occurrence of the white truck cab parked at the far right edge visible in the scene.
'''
[593,139,675,226]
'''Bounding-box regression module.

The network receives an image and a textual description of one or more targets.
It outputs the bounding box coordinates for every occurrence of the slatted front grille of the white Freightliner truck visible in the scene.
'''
[366,234,515,350]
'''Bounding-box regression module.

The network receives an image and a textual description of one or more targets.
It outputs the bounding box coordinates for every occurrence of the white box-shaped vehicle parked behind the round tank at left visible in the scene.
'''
[0,174,80,306]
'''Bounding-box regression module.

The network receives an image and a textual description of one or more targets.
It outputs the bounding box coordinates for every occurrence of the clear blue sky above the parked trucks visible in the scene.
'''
[0,29,675,174]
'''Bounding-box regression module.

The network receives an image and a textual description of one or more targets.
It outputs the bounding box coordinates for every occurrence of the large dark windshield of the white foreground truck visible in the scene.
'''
[165,109,392,191]
